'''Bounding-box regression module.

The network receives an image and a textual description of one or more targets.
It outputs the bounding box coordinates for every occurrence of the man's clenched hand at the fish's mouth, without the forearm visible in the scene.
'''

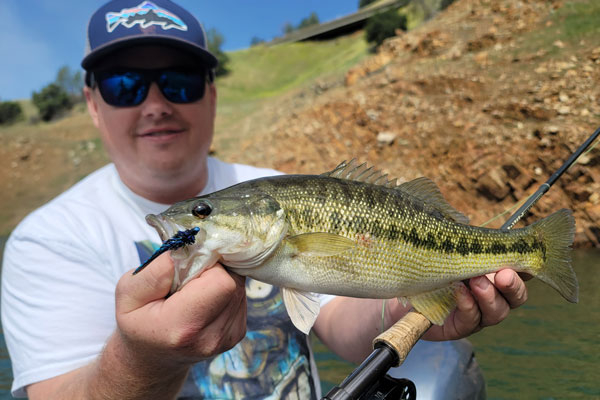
[116,254,246,365]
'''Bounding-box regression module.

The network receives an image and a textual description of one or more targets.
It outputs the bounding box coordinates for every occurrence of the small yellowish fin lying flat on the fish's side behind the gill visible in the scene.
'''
[286,232,356,257]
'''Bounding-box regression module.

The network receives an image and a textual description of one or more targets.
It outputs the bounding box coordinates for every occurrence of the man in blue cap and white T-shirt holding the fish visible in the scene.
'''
[2,0,526,400]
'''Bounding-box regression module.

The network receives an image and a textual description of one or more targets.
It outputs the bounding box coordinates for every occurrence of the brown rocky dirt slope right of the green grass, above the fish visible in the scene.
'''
[225,0,600,247]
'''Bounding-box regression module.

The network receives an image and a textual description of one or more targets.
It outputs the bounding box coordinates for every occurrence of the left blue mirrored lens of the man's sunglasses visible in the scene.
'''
[98,71,150,107]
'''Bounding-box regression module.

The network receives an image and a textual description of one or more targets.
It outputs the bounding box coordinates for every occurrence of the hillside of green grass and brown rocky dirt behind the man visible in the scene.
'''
[0,0,600,247]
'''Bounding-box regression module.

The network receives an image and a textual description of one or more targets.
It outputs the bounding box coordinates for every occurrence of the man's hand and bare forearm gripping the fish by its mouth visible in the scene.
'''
[27,254,246,400]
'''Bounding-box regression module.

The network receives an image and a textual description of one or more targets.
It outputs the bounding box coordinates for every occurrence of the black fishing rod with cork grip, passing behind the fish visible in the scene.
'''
[322,127,600,400]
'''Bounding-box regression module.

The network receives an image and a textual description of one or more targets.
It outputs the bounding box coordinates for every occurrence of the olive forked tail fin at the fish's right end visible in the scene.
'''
[531,209,579,303]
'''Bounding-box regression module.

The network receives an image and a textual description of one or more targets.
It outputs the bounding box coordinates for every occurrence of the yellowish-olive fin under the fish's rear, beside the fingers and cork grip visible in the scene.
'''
[408,283,460,325]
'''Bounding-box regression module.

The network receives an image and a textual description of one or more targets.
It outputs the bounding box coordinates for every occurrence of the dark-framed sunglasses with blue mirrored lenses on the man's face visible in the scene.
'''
[89,68,212,107]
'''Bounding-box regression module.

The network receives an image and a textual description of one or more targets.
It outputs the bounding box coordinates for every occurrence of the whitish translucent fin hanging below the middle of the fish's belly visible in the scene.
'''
[281,288,321,335]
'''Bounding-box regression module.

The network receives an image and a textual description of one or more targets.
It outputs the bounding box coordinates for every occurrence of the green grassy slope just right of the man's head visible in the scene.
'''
[215,32,369,155]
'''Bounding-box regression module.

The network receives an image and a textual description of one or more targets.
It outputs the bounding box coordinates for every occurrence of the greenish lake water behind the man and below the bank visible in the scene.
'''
[0,248,600,400]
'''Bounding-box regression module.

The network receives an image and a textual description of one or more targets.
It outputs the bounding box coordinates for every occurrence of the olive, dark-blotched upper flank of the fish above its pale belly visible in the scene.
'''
[262,179,546,258]
